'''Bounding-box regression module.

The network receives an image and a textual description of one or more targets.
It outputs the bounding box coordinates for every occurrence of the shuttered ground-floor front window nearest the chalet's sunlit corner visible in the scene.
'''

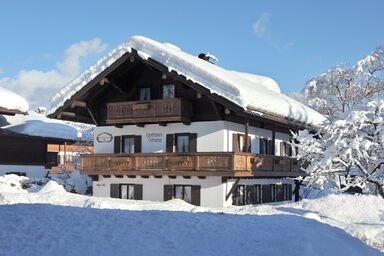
[164,185,201,206]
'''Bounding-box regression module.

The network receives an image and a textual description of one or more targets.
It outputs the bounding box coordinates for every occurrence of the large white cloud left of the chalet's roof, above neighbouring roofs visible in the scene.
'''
[0,38,106,109]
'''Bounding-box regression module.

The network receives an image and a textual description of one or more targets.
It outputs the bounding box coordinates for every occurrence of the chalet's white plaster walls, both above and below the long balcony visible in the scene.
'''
[93,121,292,207]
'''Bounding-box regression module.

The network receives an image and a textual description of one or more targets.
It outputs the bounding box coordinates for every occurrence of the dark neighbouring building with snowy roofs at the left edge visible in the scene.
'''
[0,87,93,178]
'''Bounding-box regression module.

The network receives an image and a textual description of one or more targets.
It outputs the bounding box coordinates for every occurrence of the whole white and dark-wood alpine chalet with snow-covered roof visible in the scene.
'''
[48,36,324,207]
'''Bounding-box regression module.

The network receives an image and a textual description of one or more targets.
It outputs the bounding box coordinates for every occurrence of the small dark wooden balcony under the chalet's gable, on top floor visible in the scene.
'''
[106,99,192,124]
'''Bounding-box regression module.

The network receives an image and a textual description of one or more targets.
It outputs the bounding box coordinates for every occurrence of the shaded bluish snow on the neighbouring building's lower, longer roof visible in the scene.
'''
[0,111,93,141]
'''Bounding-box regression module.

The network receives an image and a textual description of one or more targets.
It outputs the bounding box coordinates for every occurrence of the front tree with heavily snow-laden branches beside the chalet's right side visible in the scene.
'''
[295,99,384,198]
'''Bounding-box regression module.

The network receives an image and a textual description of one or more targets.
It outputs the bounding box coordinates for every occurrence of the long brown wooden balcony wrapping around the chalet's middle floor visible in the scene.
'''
[81,152,305,177]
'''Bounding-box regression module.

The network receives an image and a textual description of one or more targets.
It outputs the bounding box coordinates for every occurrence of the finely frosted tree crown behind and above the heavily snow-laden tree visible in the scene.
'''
[303,48,384,120]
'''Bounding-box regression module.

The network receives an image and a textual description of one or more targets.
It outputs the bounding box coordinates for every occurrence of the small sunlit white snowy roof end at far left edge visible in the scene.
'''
[0,87,29,112]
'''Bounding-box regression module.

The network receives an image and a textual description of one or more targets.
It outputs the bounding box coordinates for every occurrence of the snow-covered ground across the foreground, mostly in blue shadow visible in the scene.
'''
[0,175,384,256]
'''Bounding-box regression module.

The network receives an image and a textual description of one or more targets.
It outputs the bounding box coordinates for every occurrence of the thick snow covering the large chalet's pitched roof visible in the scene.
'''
[48,36,325,126]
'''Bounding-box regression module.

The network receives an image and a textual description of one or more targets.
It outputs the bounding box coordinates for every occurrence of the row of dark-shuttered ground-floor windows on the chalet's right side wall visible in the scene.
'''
[232,184,292,205]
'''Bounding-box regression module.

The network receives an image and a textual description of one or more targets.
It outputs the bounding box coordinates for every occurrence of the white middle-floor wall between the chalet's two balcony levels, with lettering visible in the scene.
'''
[94,121,289,154]
